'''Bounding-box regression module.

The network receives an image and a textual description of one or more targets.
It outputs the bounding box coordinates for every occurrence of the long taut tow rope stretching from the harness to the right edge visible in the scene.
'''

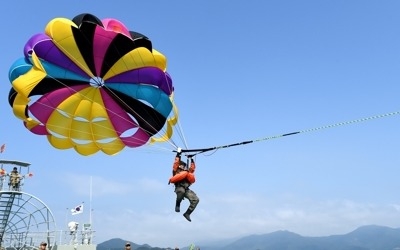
[180,111,400,157]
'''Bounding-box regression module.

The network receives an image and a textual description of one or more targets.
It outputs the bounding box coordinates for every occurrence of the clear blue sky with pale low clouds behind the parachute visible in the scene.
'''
[0,0,400,247]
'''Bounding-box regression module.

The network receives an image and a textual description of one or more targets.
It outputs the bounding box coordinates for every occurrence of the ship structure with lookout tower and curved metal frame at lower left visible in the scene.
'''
[0,160,97,250]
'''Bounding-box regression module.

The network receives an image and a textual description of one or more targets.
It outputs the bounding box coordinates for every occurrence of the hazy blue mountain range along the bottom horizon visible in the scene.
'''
[97,225,400,250]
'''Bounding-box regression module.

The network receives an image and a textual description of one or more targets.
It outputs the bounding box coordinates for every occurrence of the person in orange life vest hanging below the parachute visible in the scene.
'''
[168,148,200,221]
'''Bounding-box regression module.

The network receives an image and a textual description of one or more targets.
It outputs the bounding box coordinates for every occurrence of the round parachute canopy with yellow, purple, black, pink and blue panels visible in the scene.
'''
[9,14,177,155]
